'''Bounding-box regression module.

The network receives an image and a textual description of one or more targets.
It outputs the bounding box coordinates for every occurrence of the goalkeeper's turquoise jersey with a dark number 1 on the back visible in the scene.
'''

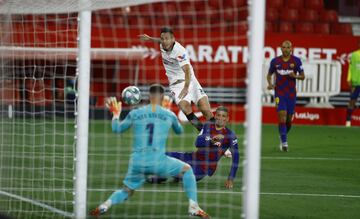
[112,104,184,162]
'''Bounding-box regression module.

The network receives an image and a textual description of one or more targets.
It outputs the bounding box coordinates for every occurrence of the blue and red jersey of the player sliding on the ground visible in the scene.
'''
[192,123,239,180]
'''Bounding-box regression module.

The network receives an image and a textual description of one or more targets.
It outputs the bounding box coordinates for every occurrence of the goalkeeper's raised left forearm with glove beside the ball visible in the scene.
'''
[105,97,132,133]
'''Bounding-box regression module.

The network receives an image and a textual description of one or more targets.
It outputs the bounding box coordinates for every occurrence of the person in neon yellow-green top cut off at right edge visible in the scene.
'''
[346,41,360,127]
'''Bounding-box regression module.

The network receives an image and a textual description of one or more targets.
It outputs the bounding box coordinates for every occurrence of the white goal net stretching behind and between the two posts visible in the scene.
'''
[0,0,261,218]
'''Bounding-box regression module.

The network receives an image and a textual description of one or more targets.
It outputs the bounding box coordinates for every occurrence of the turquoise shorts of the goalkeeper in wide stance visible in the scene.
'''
[123,155,186,190]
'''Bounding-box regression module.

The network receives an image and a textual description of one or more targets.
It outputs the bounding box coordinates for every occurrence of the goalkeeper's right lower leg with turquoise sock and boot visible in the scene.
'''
[183,165,210,218]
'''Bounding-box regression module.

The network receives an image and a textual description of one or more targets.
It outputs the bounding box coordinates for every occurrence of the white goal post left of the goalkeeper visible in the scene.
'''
[74,5,91,219]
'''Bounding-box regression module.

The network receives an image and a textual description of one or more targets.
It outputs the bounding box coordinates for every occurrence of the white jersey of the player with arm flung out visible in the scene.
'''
[160,42,195,84]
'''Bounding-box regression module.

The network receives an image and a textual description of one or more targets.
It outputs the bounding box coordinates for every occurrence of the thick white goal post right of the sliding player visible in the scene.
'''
[243,0,265,219]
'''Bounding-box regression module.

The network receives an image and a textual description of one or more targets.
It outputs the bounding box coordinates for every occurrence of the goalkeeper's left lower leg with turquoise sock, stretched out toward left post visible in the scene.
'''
[90,186,134,216]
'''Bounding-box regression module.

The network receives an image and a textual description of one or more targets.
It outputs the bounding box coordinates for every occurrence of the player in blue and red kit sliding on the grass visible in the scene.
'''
[147,106,239,189]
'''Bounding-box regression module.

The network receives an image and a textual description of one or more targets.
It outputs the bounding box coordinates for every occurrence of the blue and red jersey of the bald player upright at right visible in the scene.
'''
[269,55,304,98]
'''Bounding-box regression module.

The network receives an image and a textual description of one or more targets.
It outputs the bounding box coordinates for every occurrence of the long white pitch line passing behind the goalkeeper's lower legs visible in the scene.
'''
[88,189,360,198]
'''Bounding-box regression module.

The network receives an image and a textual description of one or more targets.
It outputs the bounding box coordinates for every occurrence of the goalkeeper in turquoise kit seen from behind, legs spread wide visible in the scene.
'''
[90,84,210,218]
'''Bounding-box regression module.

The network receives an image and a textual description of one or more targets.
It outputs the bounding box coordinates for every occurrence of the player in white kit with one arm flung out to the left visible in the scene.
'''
[140,27,214,131]
